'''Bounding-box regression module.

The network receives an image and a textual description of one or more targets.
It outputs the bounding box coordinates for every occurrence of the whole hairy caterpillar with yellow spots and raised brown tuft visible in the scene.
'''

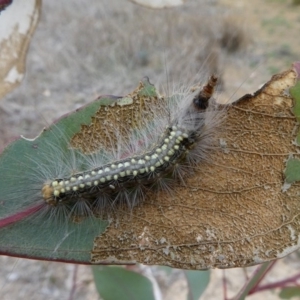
[42,76,217,213]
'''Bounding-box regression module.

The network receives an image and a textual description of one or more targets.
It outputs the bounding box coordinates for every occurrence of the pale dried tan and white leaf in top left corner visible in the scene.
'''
[0,0,41,98]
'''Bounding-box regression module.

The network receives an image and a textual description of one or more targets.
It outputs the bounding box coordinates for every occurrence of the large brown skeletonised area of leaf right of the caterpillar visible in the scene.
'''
[92,70,300,269]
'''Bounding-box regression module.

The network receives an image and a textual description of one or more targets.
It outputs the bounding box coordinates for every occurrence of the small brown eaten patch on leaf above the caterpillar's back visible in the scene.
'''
[71,78,161,153]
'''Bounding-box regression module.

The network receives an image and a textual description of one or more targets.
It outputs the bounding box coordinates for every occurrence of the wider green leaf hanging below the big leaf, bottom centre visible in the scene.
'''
[92,266,155,300]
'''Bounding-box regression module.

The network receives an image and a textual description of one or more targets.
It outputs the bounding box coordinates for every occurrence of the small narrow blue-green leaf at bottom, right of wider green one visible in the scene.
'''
[184,271,210,300]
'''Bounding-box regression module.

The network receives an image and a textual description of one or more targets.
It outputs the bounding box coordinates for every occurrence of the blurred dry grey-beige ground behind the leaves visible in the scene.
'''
[0,0,300,299]
